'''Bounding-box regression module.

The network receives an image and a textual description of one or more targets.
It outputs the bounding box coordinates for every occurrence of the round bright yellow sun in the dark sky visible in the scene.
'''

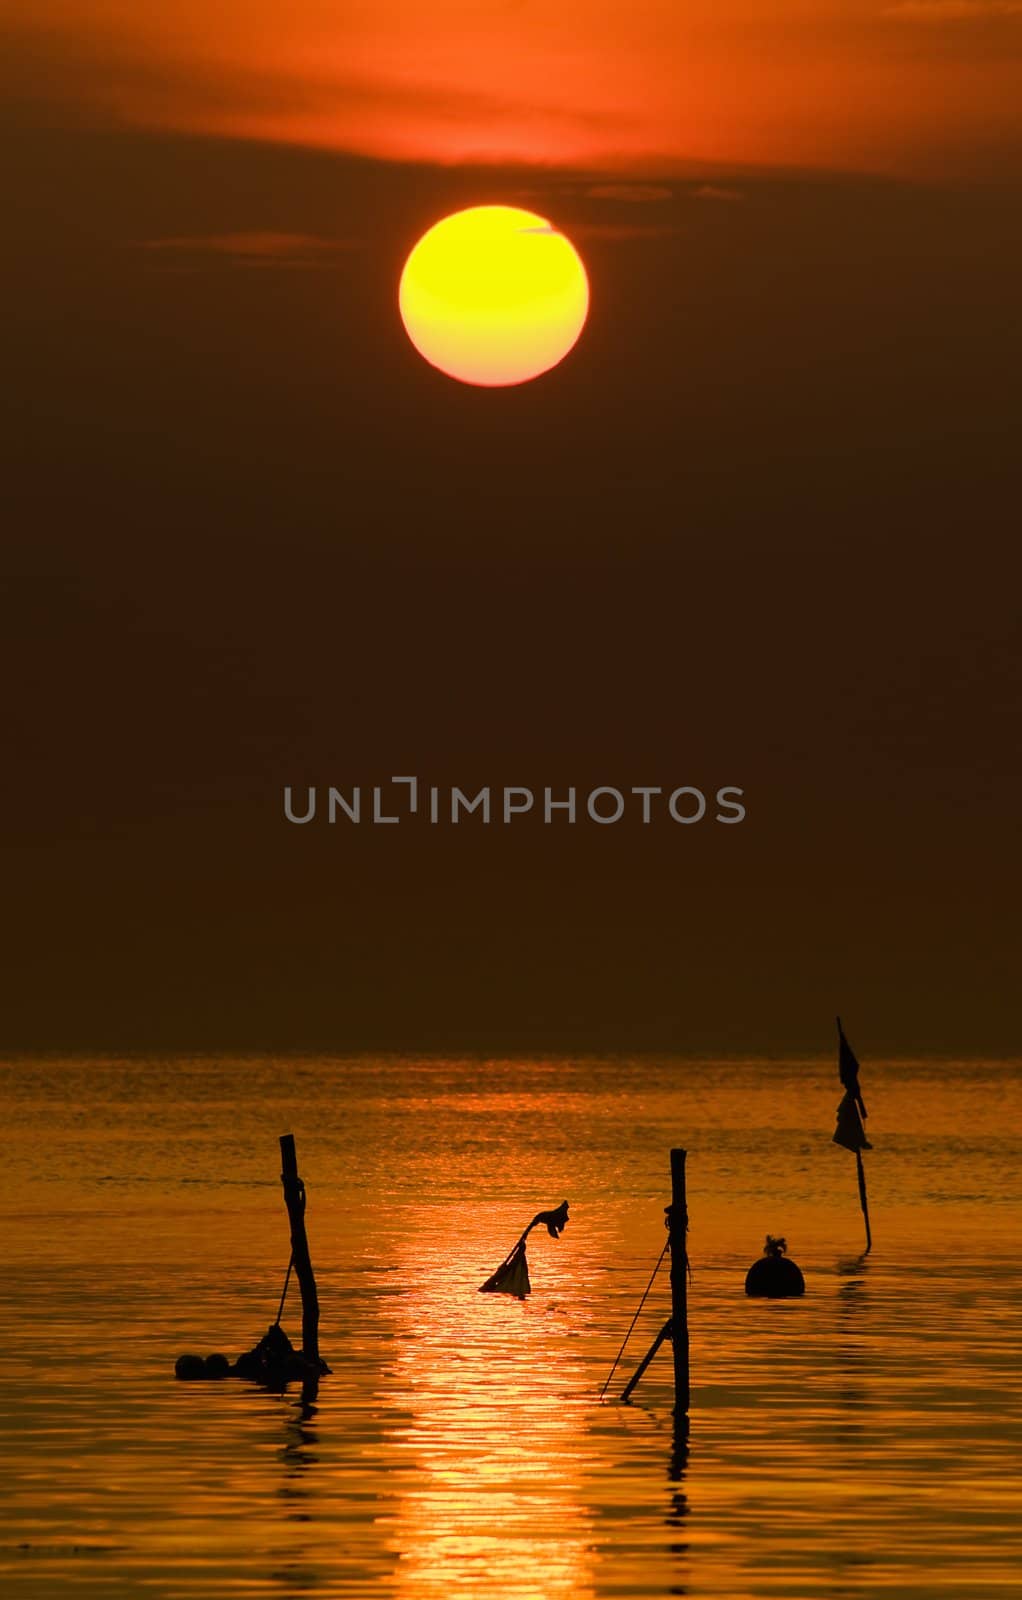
[398,205,589,389]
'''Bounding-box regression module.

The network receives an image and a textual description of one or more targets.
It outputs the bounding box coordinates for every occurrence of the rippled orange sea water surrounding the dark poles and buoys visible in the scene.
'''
[0,1059,1022,1600]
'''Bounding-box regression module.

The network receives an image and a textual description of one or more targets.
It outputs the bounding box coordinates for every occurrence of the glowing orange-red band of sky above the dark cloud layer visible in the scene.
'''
[3,0,1022,174]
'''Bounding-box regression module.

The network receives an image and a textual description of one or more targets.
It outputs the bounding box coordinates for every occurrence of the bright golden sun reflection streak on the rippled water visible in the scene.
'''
[380,1208,595,1600]
